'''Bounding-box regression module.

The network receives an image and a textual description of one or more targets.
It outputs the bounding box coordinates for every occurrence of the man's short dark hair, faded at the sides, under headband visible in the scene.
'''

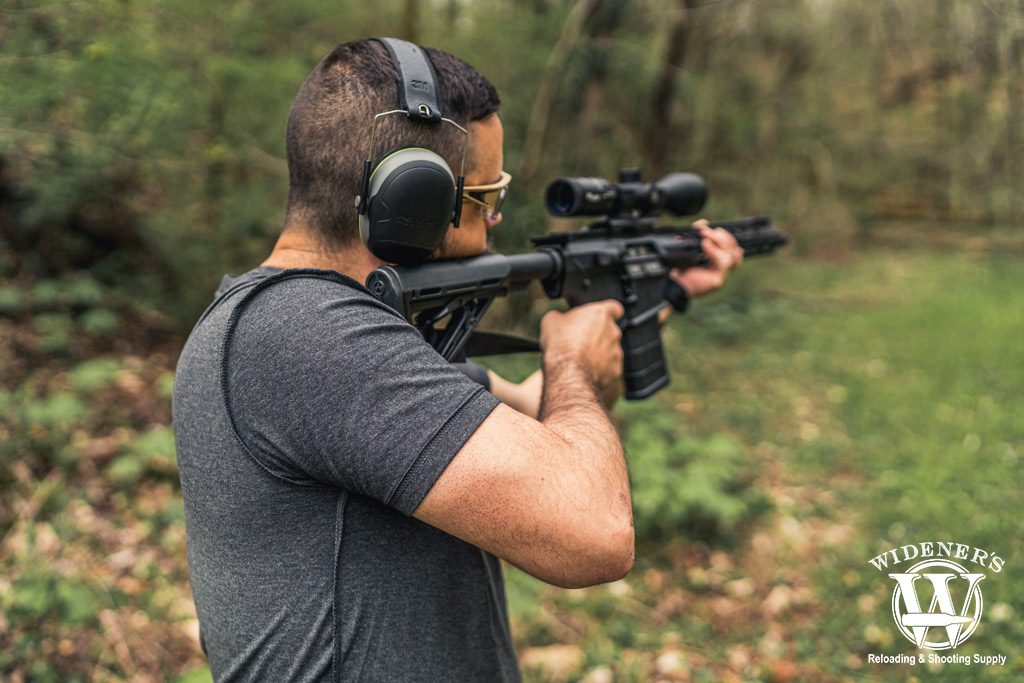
[285,39,501,251]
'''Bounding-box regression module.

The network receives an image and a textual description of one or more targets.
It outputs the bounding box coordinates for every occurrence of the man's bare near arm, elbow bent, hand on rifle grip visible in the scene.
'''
[414,301,633,588]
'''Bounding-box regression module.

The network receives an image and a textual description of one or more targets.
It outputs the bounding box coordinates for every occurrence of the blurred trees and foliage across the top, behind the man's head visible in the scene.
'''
[0,0,1024,323]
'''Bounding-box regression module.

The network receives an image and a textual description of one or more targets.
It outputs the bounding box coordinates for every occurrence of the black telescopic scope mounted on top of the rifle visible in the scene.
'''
[544,169,708,218]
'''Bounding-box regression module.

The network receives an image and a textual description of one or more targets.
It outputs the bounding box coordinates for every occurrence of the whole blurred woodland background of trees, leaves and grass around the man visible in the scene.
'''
[0,0,1024,683]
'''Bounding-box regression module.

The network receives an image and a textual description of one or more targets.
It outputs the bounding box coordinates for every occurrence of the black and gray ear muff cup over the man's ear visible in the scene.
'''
[359,147,456,265]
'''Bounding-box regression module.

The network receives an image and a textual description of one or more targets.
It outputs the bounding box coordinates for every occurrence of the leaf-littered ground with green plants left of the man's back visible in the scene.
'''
[0,278,193,681]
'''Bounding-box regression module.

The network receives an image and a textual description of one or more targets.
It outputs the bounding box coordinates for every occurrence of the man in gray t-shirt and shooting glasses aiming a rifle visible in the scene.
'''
[174,41,741,681]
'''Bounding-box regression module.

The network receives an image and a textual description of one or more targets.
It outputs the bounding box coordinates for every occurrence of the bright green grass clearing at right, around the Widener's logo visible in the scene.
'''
[746,253,1024,680]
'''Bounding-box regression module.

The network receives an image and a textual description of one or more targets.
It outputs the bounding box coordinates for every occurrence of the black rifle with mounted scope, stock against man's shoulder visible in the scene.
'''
[367,169,787,399]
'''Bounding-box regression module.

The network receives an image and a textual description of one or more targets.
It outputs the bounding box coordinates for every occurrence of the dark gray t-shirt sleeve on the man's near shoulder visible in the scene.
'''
[223,279,499,514]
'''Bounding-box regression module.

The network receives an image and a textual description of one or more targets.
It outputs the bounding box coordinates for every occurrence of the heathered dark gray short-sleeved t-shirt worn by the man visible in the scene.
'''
[174,267,519,683]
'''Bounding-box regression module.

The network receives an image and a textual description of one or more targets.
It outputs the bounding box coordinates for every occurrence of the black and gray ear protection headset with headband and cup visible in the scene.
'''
[355,38,469,265]
